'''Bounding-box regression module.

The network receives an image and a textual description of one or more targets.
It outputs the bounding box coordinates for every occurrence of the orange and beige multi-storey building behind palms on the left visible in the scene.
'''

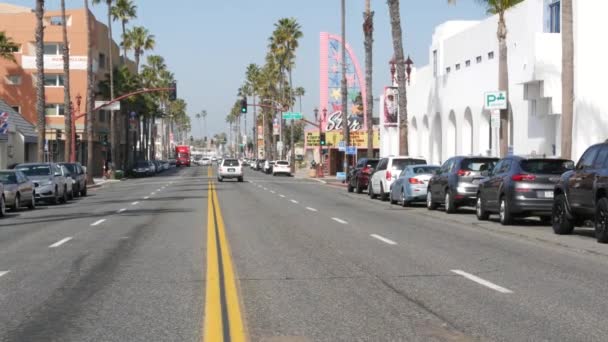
[0,3,134,175]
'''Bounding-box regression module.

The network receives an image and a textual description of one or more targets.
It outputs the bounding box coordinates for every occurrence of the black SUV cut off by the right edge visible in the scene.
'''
[552,143,608,243]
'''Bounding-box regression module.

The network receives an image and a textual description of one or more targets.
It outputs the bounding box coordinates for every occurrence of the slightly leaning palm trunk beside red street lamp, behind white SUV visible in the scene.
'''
[388,0,409,155]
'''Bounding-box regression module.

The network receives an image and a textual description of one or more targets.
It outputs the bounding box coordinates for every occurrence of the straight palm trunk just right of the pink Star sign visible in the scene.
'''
[363,0,374,158]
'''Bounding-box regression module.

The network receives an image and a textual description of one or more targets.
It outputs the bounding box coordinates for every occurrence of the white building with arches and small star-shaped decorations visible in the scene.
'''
[396,0,608,164]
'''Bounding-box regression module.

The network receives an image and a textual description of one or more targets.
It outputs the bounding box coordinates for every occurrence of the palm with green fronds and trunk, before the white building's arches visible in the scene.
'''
[448,0,523,157]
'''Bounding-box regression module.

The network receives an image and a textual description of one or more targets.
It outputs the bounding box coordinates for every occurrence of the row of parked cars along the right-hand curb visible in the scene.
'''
[346,150,608,243]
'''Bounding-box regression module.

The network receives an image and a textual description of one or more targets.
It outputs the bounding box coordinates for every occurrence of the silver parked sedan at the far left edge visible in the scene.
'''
[0,170,36,211]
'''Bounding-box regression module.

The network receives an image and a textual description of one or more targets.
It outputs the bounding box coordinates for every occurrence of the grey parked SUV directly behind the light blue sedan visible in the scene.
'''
[426,156,498,214]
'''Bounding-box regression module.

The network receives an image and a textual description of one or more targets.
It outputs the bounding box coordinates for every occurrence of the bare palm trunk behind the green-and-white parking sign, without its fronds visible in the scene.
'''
[496,12,510,157]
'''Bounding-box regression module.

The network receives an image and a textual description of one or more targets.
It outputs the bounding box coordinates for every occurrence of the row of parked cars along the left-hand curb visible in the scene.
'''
[0,163,87,216]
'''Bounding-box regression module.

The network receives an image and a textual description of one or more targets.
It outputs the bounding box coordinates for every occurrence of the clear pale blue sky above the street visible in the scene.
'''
[5,0,485,136]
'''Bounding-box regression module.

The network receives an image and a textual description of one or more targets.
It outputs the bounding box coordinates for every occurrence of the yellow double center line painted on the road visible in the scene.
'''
[204,168,246,342]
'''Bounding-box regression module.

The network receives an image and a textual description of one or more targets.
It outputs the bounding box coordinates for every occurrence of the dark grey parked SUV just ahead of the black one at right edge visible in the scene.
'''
[475,156,574,225]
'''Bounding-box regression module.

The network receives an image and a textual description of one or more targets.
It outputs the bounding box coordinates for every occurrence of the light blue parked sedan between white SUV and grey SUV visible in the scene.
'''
[389,165,439,207]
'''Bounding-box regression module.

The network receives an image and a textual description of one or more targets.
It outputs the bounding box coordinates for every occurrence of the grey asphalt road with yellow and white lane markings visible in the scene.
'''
[0,167,608,341]
